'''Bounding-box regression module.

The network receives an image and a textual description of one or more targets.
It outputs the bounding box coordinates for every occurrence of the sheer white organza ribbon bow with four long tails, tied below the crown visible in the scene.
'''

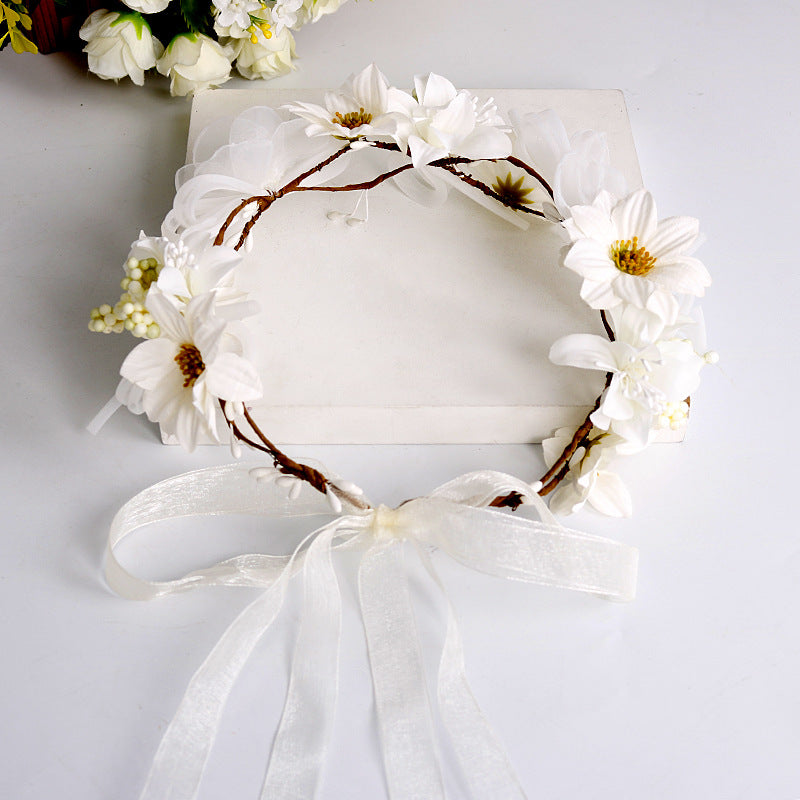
[106,464,637,800]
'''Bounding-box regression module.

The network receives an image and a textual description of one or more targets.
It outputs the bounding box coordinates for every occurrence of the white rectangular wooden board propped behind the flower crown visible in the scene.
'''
[172,89,642,444]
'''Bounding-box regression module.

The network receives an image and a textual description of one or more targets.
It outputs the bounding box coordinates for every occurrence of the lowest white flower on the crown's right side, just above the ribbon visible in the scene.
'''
[542,428,633,517]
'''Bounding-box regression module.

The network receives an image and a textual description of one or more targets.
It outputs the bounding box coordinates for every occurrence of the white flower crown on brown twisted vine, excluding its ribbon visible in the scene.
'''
[89,65,717,516]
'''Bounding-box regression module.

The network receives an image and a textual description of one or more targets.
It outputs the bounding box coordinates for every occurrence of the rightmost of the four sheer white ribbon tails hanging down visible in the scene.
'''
[415,542,525,800]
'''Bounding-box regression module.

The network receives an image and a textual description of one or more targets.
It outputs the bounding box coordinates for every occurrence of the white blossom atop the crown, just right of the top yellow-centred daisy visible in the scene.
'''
[389,73,512,167]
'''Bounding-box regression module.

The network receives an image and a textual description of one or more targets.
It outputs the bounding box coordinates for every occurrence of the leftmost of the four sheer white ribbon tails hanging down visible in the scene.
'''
[140,562,292,800]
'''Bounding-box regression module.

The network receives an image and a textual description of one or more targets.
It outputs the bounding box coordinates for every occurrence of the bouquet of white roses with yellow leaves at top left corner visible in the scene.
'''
[0,0,358,96]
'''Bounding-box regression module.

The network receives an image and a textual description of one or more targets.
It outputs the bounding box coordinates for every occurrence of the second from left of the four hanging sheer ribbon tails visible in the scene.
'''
[261,527,342,800]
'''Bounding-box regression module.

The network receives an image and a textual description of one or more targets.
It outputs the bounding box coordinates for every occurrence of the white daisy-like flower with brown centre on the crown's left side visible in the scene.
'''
[120,292,261,451]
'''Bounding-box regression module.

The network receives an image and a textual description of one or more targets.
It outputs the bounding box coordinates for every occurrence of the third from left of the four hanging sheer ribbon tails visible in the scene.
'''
[358,542,445,800]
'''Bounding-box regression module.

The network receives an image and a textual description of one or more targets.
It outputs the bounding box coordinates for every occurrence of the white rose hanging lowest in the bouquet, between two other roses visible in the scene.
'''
[156,33,231,97]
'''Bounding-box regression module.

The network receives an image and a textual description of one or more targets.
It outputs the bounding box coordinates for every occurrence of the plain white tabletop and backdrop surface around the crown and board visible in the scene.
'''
[0,0,800,800]
